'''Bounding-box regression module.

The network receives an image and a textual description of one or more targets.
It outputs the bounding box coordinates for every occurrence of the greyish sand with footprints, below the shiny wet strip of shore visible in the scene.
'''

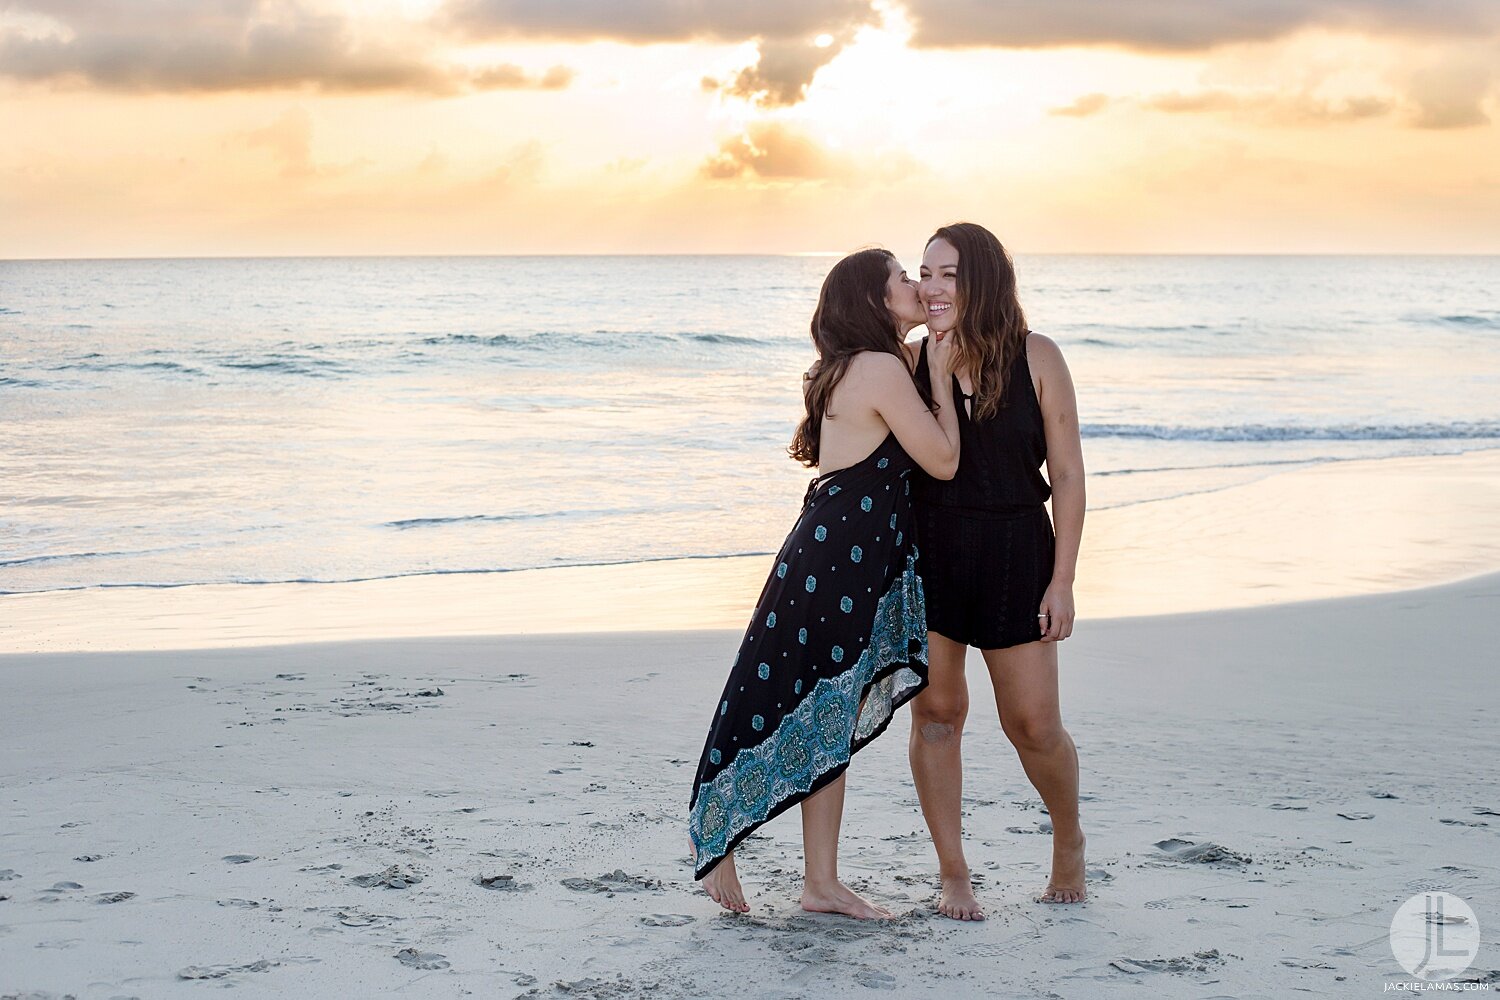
[0,560,1500,999]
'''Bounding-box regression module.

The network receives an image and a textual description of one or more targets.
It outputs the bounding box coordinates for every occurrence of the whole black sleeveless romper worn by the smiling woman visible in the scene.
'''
[912,340,1053,649]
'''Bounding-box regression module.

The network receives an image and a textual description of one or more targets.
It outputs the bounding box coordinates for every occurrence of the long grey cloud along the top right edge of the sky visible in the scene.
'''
[903,0,1500,51]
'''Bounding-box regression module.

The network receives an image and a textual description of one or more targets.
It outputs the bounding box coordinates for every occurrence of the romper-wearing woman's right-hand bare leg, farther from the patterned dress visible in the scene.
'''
[984,642,1086,903]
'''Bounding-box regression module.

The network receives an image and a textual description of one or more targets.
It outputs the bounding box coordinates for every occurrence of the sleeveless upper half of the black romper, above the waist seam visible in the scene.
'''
[912,334,1052,517]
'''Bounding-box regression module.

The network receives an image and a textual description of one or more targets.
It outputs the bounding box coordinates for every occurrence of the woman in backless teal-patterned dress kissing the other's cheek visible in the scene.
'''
[689,250,959,918]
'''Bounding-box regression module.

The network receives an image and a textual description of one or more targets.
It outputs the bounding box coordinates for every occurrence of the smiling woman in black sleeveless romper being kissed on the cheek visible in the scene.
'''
[911,223,1085,921]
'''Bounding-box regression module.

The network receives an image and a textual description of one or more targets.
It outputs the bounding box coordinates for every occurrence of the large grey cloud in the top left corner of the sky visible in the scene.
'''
[0,0,572,93]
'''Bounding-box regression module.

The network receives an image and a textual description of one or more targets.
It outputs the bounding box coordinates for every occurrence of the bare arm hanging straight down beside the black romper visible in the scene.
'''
[1026,333,1088,642]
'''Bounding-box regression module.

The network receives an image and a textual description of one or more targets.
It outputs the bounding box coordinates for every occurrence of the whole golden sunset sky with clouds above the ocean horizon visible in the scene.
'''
[0,0,1500,258]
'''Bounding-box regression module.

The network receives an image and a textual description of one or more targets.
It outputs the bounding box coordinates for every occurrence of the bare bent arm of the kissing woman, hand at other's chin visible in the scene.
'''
[846,349,959,480]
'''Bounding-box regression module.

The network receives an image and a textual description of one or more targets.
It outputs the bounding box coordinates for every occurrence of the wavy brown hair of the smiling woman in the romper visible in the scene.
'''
[927,222,1028,420]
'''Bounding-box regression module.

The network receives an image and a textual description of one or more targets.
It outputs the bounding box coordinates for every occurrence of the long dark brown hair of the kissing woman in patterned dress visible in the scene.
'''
[786,247,932,466]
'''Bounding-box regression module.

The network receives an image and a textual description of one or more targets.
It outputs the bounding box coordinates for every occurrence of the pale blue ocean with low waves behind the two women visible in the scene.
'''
[0,250,1500,594]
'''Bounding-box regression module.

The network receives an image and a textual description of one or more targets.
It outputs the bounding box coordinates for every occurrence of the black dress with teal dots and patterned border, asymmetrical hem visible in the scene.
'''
[689,435,927,879]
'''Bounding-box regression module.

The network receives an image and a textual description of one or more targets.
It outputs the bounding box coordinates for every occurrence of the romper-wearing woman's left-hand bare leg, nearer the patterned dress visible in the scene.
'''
[909,633,984,921]
